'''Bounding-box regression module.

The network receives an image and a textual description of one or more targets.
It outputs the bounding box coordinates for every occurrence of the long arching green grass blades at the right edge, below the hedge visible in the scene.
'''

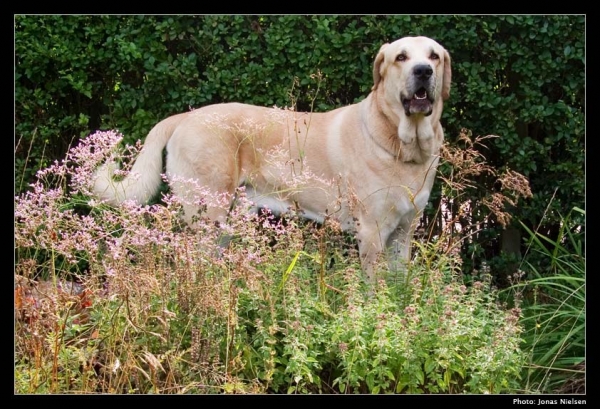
[506,207,586,393]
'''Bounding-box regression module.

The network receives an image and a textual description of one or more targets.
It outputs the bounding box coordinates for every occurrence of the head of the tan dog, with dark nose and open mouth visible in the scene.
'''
[373,37,452,116]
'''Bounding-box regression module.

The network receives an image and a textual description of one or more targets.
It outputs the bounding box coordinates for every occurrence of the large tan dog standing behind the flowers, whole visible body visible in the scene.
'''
[95,37,451,278]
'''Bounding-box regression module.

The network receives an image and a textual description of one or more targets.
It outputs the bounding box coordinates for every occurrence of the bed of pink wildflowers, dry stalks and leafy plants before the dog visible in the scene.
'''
[14,132,525,394]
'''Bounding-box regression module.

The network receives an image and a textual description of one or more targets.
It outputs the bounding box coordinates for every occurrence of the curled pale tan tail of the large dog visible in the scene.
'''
[94,114,187,205]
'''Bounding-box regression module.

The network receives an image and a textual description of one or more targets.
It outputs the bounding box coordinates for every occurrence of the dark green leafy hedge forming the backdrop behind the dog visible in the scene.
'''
[15,15,585,274]
